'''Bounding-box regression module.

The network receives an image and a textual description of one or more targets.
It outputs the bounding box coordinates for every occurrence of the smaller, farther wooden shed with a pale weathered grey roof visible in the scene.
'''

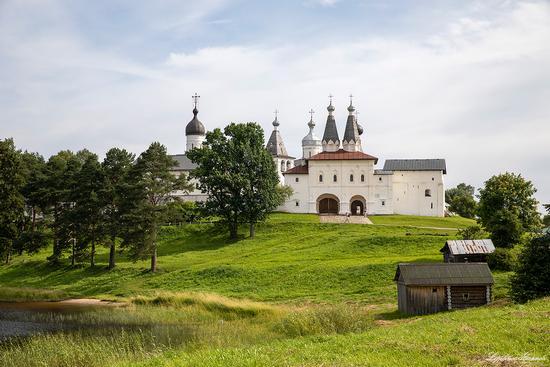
[439,239,495,263]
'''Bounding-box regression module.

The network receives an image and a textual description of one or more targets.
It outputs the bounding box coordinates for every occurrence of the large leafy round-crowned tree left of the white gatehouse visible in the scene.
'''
[187,123,286,239]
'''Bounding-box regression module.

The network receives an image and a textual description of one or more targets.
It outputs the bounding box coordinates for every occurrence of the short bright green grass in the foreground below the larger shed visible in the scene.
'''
[125,298,550,367]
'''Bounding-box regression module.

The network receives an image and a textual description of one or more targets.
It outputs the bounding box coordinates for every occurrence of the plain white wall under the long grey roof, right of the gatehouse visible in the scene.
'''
[393,171,445,217]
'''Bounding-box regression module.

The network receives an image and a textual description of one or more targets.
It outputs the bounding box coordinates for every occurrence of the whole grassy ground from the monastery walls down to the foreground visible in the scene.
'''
[0,214,550,367]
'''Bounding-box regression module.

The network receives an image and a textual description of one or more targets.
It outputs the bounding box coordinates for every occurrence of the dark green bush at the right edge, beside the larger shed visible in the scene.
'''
[511,234,550,303]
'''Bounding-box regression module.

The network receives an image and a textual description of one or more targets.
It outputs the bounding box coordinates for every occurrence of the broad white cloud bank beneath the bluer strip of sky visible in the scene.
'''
[0,2,550,207]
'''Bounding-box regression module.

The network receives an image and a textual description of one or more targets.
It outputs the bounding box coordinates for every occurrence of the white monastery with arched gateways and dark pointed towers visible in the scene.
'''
[172,98,447,217]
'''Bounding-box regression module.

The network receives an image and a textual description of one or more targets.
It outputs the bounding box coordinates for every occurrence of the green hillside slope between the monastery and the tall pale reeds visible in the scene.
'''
[0,214,478,304]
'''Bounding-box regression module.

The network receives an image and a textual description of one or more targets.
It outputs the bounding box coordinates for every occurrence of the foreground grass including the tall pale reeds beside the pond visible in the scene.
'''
[0,294,550,367]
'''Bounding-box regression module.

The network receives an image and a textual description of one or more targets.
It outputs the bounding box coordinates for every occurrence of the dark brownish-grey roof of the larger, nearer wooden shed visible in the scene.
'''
[393,263,494,286]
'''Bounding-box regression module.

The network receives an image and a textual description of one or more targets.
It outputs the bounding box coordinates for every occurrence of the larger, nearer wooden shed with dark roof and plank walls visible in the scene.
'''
[394,263,494,315]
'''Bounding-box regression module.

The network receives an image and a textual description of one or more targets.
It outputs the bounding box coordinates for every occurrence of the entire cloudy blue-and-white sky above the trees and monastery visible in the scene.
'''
[0,0,550,211]
